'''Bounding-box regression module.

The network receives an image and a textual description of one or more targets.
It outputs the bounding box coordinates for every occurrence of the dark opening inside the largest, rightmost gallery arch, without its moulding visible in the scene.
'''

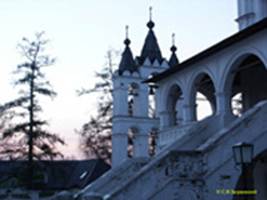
[226,55,267,117]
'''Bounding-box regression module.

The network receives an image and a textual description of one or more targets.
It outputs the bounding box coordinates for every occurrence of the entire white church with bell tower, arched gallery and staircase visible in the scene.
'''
[76,0,267,200]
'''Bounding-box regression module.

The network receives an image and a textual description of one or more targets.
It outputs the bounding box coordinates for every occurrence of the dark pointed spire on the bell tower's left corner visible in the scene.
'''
[119,26,137,75]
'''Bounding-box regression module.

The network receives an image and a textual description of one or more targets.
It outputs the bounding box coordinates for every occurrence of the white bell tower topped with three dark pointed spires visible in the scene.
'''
[112,8,178,167]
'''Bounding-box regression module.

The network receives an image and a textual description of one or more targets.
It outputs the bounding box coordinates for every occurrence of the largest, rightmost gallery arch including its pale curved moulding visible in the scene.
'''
[223,48,267,116]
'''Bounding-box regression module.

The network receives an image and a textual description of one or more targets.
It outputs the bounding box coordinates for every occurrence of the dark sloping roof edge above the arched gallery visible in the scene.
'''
[144,18,267,83]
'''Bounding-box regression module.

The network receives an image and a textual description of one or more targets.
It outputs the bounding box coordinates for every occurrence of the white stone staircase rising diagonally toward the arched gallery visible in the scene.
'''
[76,102,267,200]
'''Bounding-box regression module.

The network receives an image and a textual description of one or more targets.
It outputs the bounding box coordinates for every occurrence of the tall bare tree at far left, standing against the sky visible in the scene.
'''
[0,32,64,186]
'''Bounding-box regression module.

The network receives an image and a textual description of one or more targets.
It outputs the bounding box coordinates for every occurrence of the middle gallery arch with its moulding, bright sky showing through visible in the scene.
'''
[185,69,217,121]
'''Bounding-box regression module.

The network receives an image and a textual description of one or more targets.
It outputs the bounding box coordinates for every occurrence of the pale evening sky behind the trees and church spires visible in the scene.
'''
[0,0,238,159]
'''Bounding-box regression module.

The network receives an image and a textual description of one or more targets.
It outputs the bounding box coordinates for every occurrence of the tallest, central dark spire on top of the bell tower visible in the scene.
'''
[140,7,162,64]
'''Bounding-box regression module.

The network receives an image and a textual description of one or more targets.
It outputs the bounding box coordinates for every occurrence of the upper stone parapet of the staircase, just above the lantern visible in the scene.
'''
[197,101,267,176]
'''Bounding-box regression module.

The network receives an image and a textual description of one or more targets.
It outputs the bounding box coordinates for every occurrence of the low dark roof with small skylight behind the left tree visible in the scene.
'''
[0,159,110,190]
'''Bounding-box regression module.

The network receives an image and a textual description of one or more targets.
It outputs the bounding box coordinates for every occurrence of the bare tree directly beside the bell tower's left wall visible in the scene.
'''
[77,49,119,163]
